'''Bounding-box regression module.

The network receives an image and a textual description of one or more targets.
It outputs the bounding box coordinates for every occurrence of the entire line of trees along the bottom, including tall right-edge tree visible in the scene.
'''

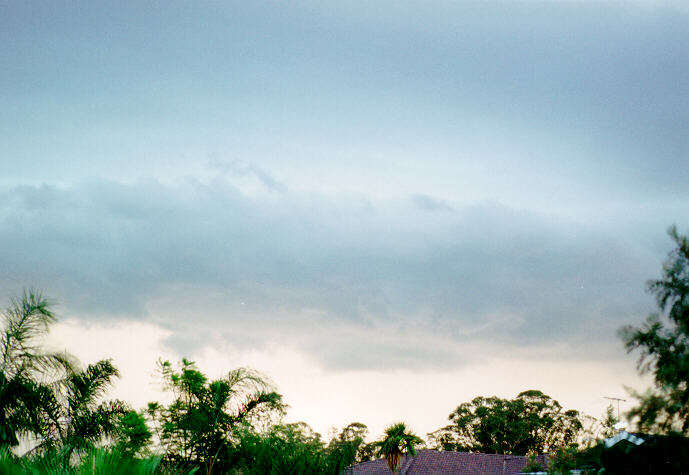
[0,227,689,474]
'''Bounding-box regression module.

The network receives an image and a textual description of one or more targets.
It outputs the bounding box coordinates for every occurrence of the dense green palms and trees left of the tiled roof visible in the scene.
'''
[0,292,374,473]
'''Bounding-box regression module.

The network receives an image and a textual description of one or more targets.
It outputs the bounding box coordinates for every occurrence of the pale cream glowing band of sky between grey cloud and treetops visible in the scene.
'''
[48,320,649,439]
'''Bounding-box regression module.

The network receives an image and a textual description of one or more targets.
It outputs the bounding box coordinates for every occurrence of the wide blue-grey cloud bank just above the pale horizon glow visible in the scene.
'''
[0,180,662,365]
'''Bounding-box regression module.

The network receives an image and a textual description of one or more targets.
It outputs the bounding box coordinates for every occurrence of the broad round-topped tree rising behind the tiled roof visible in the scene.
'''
[429,390,583,455]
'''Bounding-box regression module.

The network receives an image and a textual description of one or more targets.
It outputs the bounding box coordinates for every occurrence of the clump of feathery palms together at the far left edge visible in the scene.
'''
[0,290,127,462]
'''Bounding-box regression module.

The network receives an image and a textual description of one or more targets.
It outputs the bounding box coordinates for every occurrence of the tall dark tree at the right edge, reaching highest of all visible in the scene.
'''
[620,226,689,434]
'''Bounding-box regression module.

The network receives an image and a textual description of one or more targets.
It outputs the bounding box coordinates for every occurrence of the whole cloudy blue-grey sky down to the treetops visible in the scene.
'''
[0,0,689,438]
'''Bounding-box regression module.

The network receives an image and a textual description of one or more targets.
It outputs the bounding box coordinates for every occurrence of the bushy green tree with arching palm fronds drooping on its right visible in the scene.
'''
[148,359,284,473]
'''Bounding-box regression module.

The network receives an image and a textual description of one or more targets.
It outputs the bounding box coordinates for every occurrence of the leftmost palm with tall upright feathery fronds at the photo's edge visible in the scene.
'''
[0,290,74,447]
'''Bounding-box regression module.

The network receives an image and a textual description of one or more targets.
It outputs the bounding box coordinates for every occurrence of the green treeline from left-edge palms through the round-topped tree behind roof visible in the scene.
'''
[0,292,592,474]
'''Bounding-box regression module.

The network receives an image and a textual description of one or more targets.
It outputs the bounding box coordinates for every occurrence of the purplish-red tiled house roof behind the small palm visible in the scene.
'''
[345,449,547,475]
